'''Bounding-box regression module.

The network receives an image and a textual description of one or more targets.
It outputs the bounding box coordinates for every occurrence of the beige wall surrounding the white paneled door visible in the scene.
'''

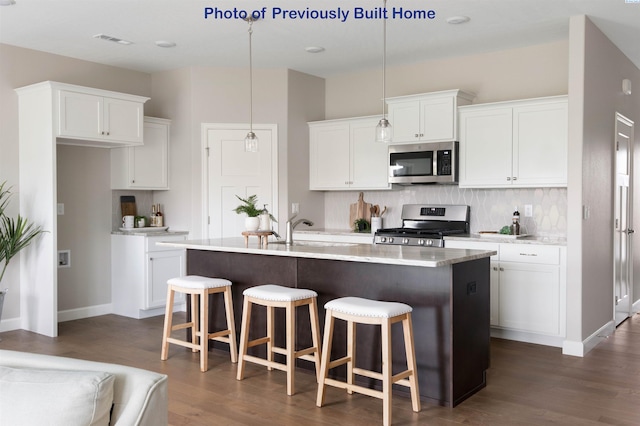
[149,67,324,238]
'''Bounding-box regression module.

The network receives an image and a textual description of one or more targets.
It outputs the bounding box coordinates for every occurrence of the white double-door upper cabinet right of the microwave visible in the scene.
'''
[459,96,568,188]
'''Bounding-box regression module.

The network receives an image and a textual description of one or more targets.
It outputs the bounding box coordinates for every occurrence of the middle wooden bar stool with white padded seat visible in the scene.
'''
[237,284,320,395]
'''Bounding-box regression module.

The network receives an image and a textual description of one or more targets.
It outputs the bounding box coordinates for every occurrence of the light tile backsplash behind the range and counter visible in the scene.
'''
[324,185,567,238]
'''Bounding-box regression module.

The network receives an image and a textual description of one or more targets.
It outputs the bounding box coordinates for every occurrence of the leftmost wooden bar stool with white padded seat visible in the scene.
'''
[160,275,238,372]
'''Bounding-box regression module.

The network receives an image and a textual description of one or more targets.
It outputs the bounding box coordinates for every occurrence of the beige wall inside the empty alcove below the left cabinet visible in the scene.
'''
[57,145,111,312]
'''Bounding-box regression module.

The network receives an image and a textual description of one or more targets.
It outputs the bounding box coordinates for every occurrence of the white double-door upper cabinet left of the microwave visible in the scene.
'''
[309,117,391,190]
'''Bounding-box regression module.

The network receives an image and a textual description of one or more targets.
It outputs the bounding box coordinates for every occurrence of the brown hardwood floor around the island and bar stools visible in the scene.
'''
[0,315,640,426]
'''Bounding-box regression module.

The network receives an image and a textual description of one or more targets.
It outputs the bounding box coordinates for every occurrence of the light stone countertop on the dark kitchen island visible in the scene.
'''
[157,238,496,268]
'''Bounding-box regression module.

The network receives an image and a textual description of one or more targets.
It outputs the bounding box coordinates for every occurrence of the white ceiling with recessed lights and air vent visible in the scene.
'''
[0,0,640,77]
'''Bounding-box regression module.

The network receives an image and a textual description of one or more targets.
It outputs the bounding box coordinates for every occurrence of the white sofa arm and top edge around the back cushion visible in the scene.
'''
[0,350,168,426]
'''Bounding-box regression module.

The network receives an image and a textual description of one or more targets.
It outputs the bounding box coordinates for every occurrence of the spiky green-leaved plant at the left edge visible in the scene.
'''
[0,181,44,318]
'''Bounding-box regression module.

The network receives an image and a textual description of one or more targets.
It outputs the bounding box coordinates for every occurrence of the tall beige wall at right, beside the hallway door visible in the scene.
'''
[567,16,640,350]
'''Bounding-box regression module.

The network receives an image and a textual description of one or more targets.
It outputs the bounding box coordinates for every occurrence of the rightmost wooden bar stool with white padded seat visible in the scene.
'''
[316,297,420,426]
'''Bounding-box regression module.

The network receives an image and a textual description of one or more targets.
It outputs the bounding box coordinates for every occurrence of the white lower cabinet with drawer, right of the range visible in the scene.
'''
[445,240,566,347]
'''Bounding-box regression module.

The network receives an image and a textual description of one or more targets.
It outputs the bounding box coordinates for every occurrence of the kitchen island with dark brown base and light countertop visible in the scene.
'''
[160,238,495,407]
